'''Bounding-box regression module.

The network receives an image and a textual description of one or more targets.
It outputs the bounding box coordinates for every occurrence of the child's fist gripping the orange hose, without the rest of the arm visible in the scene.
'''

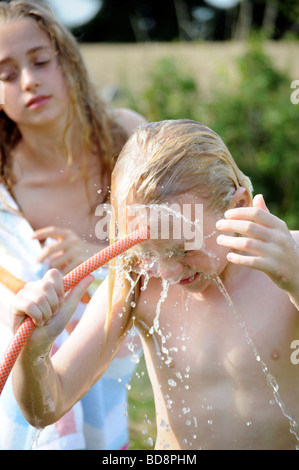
[10,269,94,345]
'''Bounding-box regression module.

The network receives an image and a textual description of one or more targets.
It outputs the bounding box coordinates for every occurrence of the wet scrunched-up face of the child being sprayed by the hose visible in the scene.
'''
[127,194,231,292]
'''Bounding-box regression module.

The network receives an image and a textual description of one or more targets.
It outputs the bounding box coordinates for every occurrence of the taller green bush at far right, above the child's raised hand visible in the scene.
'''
[207,42,299,228]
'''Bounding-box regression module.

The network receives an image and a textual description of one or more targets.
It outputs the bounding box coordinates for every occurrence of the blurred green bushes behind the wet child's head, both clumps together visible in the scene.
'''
[128,39,299,229]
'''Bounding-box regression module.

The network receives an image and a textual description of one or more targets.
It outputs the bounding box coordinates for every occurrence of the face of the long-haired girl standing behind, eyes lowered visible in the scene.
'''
[0,18,68,130]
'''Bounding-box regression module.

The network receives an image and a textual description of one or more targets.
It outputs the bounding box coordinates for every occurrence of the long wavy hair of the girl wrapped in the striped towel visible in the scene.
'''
[0,0,128,194]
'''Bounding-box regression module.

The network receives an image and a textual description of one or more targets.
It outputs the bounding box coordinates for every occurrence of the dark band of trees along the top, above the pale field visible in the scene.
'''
[65,0,299,42]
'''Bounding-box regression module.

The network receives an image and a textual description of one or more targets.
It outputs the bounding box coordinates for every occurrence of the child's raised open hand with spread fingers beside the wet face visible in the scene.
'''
[216,195,299,297]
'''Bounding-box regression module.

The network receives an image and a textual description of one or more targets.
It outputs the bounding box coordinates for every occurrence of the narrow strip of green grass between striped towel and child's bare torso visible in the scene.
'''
[128,356,156,450]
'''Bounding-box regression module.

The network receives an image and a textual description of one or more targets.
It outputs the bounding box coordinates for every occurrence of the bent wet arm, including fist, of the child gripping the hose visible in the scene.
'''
[12,270,132,427]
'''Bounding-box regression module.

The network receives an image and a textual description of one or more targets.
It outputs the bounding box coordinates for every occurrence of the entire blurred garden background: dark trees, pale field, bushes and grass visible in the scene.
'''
[41,0,299,449]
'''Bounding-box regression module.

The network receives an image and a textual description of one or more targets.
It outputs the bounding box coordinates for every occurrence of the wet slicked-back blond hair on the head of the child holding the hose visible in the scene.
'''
[111,119,252,231]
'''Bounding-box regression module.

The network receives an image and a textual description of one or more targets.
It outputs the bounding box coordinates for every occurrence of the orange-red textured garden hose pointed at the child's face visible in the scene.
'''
[0,227,150,394]
